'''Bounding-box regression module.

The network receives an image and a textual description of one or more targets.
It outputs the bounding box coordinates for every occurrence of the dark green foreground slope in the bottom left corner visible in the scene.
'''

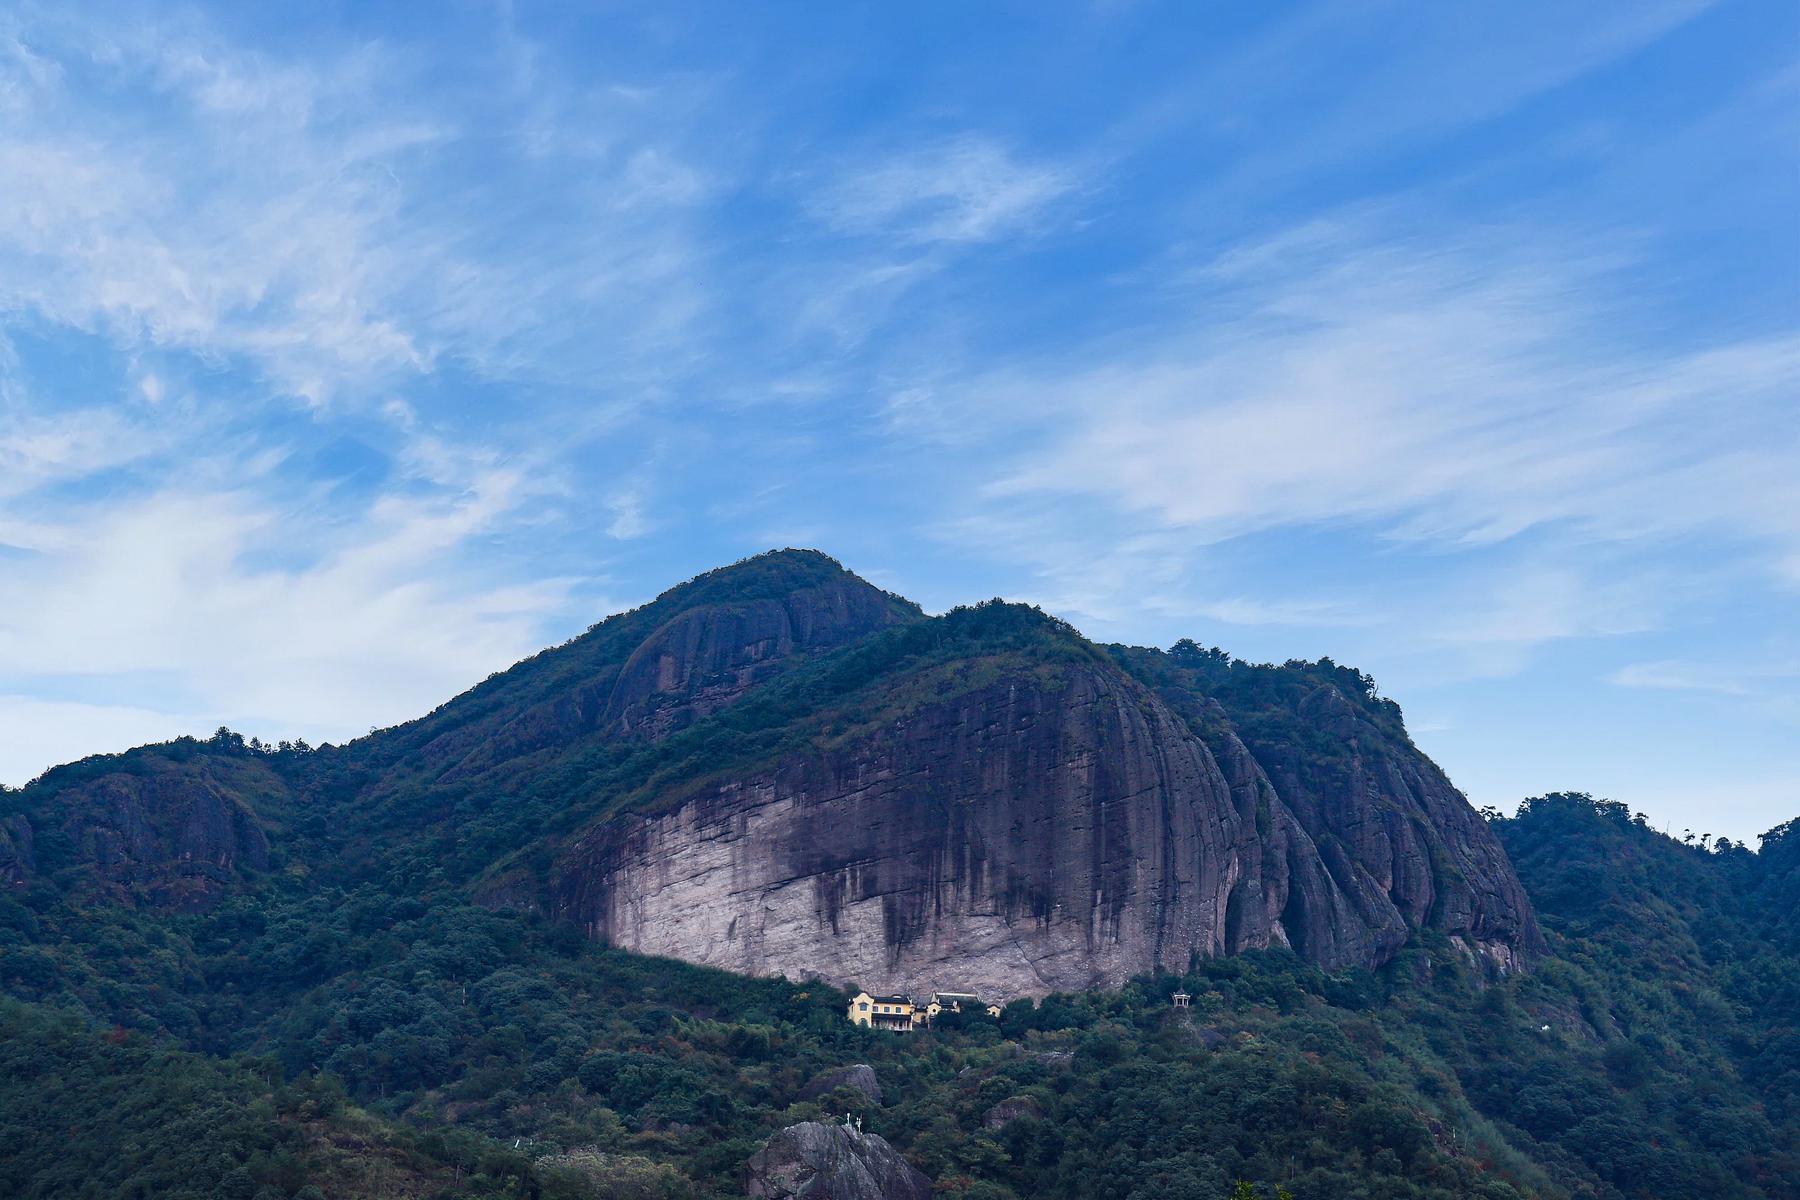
[0,999,547,1200]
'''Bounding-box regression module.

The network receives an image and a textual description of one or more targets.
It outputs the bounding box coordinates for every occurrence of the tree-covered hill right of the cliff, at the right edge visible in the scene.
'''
[1476,793,1800,1196]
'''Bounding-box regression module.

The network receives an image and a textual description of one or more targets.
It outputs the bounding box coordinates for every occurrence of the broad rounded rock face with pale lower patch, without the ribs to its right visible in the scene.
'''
[562,669,1253,997]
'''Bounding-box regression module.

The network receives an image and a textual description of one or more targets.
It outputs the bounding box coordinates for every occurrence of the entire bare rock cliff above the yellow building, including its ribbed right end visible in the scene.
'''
[549,604,1539,999]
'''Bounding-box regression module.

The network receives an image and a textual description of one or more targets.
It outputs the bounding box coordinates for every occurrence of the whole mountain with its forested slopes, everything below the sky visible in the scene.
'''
[0,551,1800,1200]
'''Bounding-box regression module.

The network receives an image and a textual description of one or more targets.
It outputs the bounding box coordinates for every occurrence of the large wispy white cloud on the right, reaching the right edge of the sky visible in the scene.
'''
[914,212,1800,628]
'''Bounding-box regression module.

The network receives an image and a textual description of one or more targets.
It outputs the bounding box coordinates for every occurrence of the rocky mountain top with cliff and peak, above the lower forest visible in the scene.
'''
[0,551,1543,999]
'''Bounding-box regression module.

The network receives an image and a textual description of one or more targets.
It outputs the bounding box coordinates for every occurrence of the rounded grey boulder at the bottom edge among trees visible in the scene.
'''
[743,1121,931,1200]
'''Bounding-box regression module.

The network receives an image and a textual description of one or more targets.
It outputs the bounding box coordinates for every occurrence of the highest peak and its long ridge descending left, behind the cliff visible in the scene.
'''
[0,552,920,907]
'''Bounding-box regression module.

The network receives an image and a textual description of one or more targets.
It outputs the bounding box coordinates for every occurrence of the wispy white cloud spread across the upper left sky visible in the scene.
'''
[0,5,706,403]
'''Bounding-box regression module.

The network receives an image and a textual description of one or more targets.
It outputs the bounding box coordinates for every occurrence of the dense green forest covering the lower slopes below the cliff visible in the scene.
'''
[0,784,1800,1200]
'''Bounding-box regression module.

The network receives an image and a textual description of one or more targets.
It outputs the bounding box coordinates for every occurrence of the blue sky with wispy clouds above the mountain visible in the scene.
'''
[0,0,1800,837]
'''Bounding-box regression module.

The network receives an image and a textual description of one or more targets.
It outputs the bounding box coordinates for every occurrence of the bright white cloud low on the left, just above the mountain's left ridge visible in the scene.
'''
[0,471,567,750]
